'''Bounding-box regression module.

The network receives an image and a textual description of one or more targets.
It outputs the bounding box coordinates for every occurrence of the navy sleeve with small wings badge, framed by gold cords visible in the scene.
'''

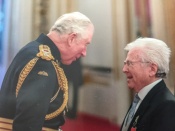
[13,59,58,131]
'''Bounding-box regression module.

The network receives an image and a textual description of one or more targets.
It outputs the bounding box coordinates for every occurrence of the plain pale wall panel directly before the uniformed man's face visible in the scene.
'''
[77,0,113,68]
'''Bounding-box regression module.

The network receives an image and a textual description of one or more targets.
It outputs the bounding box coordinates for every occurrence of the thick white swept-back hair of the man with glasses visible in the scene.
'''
[124,38,171,78]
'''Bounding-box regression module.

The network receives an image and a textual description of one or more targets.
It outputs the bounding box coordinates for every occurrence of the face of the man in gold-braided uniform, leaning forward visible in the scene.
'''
[62,25,93,65]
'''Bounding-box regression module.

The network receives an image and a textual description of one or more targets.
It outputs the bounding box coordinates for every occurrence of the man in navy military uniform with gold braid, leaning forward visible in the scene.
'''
[0,12,94,131]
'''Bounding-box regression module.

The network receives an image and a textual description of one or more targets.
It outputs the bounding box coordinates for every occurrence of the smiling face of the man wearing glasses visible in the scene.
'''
[123,50,152,92]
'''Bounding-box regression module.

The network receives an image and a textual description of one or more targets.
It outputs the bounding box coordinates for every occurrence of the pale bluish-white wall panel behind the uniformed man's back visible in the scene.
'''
[4,0,32,66]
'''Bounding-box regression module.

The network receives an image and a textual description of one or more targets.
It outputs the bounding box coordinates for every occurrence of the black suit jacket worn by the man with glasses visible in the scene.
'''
[121,80,175,131]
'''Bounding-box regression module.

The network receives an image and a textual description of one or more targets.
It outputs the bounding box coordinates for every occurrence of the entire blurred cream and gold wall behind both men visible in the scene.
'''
[0,0,175,124]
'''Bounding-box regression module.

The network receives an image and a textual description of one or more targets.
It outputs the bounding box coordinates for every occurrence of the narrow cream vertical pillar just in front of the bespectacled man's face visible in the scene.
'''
[111,0,130,124]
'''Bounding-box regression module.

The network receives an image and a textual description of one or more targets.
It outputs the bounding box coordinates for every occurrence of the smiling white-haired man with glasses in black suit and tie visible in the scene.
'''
[121,38,175,131]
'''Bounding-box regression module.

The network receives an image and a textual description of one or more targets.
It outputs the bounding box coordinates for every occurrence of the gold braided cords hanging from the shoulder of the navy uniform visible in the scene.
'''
[16,57,68,120]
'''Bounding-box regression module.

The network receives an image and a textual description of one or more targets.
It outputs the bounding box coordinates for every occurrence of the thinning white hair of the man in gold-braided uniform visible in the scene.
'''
[50,12,94,37]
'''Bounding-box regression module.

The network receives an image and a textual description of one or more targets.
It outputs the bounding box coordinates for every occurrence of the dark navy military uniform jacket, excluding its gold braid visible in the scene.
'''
[0,34,65,131]
